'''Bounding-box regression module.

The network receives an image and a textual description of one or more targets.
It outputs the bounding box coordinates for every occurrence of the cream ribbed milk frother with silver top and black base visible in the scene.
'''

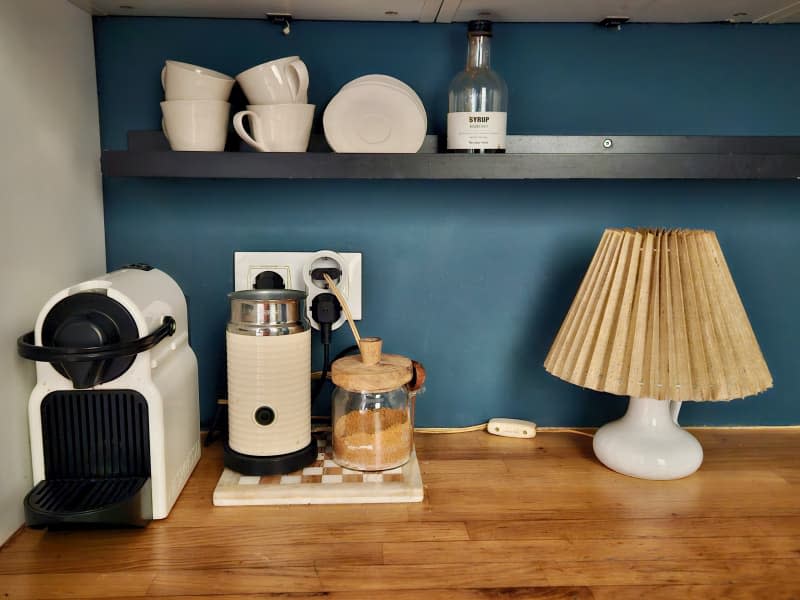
[224,289,317,475]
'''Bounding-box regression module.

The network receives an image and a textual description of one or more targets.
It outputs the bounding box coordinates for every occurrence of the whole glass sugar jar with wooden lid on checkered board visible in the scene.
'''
[331,338,425,471]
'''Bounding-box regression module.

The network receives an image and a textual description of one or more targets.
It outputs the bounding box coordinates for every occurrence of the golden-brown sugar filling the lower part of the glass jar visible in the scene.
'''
[333,408,413,471]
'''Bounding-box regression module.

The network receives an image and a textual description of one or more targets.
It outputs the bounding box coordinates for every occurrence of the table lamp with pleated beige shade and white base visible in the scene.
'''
[544,229,772,479]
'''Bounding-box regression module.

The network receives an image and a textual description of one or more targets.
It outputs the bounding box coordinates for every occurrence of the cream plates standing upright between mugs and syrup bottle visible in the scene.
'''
[322,75,428,153]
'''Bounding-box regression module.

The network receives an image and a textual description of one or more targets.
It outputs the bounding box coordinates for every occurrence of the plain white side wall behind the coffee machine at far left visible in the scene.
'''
[0,0,105,544]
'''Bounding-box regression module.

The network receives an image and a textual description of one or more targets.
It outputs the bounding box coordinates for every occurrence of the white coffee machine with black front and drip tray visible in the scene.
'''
[18,265,200,527]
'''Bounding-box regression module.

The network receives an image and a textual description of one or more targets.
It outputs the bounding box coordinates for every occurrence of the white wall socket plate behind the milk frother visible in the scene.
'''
[233,250,361,329]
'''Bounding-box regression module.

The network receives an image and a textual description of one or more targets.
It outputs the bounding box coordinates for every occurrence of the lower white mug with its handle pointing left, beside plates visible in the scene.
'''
[233,104,314,152]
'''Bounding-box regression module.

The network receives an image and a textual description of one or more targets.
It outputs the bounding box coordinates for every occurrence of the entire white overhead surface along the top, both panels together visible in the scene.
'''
[70,0,800,23]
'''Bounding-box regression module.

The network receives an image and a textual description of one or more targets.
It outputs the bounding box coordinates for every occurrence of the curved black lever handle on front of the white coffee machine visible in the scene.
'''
[17,317,176,363]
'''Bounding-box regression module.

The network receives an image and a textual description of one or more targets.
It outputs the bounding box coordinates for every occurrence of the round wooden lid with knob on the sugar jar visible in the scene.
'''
[331,338,414,393]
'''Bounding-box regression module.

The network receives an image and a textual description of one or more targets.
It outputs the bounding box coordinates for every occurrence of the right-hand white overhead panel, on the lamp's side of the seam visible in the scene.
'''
[438,0,795,23]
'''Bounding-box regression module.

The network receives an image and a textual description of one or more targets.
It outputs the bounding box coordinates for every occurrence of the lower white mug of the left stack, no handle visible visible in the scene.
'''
[161,100,231,152]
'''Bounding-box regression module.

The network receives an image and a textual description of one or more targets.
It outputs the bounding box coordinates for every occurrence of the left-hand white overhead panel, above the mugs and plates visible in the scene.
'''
[70,0,441,23]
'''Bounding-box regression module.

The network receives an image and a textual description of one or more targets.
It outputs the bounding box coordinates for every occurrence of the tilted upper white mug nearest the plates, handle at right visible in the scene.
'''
[236,56,308,105]
